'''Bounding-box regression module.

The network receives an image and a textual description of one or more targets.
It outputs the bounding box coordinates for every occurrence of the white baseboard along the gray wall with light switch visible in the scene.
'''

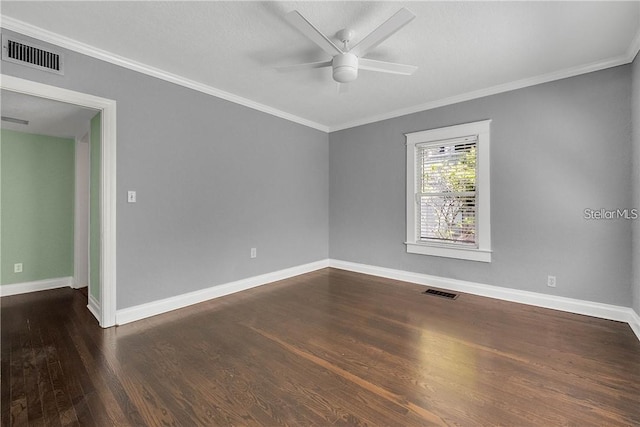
[116,260,329,325]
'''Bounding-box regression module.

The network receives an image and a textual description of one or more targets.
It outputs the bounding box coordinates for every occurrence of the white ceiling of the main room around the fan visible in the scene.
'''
[2,0,640,130]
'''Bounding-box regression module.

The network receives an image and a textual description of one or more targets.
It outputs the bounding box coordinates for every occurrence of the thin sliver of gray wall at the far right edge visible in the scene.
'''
[632,52,640,316]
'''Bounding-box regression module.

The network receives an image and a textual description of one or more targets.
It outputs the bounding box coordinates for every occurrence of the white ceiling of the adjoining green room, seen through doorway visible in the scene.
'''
[0,90,97,138]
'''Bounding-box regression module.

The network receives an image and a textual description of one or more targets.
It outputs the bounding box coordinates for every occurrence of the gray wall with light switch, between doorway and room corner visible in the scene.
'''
[2,30,329,309]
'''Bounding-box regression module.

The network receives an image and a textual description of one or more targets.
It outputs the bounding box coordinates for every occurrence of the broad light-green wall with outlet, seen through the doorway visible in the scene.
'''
[0,130,75,285]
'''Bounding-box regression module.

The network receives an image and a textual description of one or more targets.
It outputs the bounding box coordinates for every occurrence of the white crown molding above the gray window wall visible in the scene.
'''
[329,54,640,132]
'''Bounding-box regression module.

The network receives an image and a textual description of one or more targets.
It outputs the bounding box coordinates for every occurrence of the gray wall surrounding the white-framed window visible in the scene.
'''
[329,66,637,306]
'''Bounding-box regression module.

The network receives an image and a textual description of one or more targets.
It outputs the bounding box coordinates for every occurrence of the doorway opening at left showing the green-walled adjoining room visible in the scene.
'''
[0,89,100,304]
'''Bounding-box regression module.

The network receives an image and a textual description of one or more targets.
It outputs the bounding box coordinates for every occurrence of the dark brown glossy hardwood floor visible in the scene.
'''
[1,269,640,426]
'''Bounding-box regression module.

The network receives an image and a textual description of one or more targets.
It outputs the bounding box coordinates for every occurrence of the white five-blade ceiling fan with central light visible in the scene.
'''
[279,8,418,83]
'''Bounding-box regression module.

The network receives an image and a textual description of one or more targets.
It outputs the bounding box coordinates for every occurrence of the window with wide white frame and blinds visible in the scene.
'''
[406,120,491,262]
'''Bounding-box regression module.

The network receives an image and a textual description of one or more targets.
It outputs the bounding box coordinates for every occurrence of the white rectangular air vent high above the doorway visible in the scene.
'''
[2,35,64,74]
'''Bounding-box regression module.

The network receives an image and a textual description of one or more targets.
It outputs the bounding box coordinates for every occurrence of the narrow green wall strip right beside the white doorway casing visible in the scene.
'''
[89,113,102,301]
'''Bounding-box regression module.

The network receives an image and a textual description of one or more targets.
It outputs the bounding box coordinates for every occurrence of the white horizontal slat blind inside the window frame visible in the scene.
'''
[416,135,478,247]
